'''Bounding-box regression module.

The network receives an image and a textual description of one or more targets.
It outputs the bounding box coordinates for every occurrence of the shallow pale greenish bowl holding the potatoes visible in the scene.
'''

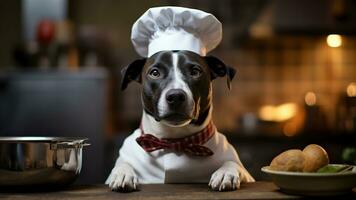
[261,164,356,196]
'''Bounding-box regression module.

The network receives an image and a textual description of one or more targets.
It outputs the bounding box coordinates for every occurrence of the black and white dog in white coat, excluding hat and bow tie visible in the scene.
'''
[106,50,254,191]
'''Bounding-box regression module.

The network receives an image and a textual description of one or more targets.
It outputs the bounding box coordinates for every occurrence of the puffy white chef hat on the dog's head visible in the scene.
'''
[131,6,222,57]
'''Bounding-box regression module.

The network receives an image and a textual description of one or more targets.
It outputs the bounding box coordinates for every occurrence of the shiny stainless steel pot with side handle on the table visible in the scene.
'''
[0,137,89,187]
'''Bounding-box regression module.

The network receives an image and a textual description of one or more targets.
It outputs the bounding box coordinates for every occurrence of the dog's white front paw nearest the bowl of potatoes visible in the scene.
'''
[209,163,240,191]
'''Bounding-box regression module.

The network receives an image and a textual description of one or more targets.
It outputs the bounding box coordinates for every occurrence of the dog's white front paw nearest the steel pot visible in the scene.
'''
[106,164,138,192]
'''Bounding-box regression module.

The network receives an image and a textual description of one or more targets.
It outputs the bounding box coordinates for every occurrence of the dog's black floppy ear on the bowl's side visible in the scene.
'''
[205,56,236,90]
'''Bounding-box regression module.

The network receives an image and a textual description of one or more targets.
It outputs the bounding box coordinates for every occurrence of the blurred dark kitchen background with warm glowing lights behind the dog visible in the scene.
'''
[0,0,356,183]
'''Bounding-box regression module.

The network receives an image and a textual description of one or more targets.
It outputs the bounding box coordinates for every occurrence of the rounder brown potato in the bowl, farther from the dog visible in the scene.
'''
[303,144,329,172]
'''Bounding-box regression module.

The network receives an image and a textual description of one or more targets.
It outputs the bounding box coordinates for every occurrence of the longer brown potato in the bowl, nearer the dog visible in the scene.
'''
[270,149,304,172]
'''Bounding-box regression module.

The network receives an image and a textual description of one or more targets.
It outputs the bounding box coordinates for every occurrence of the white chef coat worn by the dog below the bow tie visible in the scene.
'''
[117,129,248,183]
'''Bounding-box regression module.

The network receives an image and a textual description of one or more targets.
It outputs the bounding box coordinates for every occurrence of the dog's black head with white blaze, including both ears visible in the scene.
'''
[121,51,235,126]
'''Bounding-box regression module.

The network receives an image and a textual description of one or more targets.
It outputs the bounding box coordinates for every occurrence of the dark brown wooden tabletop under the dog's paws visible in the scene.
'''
[0,182,356,200]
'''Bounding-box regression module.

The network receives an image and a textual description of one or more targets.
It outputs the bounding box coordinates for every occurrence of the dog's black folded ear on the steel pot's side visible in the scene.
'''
[121,58,146,90]
